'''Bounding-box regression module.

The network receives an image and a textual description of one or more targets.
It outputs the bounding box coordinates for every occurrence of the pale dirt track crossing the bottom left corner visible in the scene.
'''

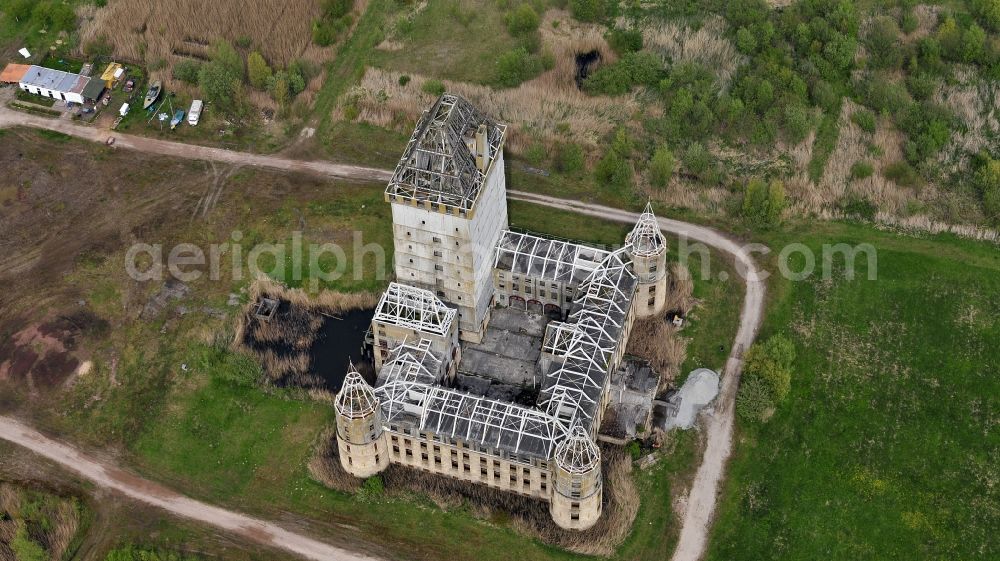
[0,417,374,561]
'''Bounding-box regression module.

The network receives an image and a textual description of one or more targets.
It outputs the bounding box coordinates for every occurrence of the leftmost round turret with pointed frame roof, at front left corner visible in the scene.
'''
[334,364,389,477]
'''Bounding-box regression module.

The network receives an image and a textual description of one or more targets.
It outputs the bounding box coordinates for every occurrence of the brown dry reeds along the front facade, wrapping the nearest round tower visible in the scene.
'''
[309,429,640,556]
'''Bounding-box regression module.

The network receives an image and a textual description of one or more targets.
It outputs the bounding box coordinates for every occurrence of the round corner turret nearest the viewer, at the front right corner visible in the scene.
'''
[549,425,602,530]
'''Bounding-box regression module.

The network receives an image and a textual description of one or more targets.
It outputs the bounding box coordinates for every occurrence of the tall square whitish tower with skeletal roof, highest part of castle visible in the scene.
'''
[385,93,507,342]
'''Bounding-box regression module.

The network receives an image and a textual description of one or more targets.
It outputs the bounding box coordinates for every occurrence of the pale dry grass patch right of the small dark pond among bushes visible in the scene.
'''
[643,16,746,89]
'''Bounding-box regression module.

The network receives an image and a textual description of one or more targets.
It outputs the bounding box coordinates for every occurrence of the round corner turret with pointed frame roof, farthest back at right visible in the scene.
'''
[625,204,667,318]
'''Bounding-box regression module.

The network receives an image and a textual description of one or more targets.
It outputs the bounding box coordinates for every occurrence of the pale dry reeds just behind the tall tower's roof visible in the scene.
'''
[348,10,637,152]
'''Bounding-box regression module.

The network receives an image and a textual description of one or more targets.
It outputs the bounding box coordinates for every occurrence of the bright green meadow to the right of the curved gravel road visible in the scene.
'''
[709,223,1000,560]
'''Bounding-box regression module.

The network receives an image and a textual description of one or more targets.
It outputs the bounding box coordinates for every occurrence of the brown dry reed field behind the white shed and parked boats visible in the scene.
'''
[81,0,340,82]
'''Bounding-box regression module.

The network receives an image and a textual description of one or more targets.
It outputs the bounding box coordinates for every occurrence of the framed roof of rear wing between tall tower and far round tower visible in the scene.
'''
[493,230,610,284]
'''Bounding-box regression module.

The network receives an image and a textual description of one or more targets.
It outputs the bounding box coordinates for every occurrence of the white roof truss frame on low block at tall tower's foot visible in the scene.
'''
[374,282,457,336]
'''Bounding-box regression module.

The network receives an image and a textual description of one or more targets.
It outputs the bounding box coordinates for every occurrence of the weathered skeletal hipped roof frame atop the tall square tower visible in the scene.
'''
[386,94,507,213]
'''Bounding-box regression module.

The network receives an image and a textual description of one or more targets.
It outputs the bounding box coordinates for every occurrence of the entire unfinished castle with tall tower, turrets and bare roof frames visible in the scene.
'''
[335,94,667,530]
